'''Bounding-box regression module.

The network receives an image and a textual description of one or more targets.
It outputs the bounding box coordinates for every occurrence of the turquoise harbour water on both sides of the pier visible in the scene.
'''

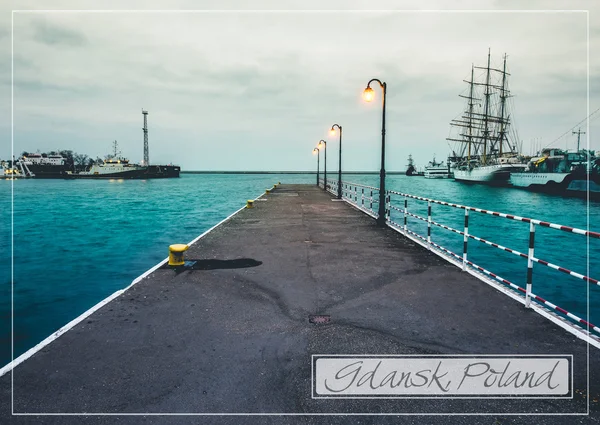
[0,175,600,364]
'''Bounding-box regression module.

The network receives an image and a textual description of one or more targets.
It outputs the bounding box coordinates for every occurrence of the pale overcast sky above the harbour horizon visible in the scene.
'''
[0,1,600,170]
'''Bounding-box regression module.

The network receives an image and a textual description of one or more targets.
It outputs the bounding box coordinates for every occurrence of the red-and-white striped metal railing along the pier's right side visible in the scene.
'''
[321,179,600,341]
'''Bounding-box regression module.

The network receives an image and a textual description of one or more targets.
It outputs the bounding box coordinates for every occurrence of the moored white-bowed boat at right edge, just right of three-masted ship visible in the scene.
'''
[510,148,600,199]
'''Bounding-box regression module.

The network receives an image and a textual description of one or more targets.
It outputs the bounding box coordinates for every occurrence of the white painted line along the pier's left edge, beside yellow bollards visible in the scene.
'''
[0,190,264,376]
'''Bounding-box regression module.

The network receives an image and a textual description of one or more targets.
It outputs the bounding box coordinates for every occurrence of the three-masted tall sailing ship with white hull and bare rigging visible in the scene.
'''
[446,51,526,184]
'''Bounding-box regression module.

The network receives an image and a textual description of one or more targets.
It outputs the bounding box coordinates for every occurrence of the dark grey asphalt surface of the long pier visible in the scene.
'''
[0,185,600,424]
